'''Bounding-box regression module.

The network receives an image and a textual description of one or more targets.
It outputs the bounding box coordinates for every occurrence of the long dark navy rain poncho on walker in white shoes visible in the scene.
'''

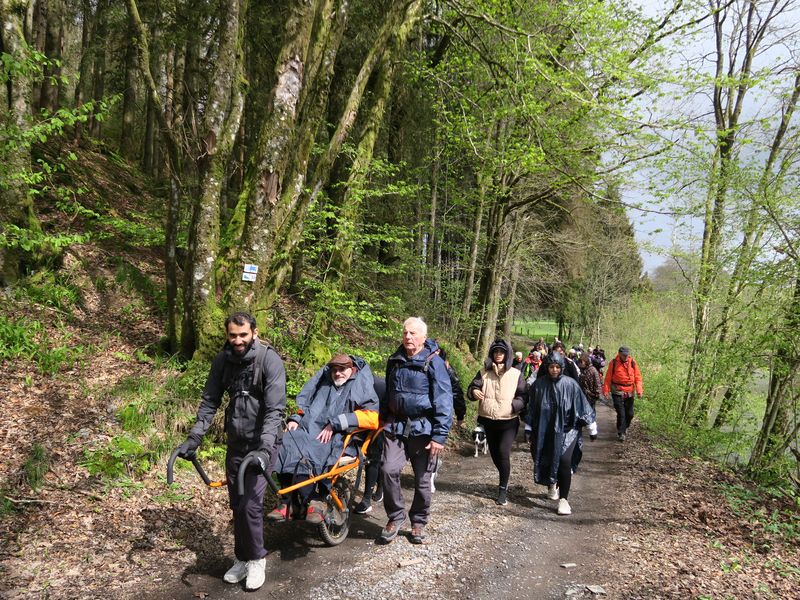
[527,352,595,485]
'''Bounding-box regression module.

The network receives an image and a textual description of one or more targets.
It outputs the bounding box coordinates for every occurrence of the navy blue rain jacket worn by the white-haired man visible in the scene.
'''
[380,338,453,444]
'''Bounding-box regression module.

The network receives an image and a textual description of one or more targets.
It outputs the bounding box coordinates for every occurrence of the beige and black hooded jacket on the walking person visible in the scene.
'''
[467,340,528,421]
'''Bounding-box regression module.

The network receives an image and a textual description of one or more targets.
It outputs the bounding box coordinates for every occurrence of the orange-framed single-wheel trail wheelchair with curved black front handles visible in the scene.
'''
[167,428,382,546]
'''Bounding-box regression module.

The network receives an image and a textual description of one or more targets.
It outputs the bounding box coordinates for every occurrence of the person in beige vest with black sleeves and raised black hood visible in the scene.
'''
[467,340,527,506]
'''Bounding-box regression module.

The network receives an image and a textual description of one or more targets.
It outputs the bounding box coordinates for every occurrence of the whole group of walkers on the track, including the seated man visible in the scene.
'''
[178,312,642,590]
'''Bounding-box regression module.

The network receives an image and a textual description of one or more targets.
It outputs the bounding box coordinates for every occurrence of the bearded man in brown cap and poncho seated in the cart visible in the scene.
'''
[269,354,378,523]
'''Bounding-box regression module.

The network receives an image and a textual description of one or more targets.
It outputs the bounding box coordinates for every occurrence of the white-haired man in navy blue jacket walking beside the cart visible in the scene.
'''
[380,317,453,544]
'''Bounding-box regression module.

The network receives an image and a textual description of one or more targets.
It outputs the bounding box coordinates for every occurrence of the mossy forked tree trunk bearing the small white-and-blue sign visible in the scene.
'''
[219,0,415,312]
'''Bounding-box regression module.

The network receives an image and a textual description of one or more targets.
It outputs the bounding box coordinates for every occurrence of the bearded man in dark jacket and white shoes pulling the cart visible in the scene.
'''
[178,312,286,590]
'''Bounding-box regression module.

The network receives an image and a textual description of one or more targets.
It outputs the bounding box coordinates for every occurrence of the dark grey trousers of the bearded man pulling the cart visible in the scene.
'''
[225,447,267,560]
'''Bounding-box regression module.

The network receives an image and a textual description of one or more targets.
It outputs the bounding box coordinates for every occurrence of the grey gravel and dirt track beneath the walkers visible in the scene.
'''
[150,406,624,600]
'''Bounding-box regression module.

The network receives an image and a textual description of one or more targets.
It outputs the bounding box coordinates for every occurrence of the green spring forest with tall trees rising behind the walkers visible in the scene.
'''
[0,0,800,596]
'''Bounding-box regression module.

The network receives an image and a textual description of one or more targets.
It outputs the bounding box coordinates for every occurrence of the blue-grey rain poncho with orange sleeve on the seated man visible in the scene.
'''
[275,356,378,475]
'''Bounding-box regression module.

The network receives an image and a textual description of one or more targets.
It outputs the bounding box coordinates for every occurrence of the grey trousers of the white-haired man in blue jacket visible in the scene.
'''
[381,433,435,525]
